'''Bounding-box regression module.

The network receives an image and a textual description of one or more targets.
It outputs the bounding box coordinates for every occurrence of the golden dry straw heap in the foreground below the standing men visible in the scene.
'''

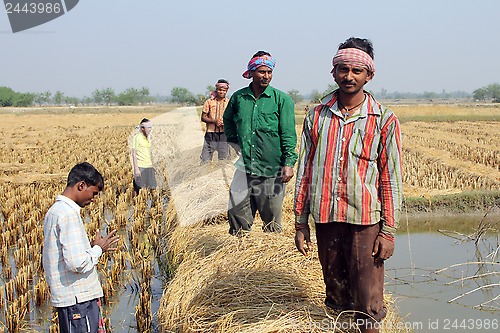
[158,220,405,333]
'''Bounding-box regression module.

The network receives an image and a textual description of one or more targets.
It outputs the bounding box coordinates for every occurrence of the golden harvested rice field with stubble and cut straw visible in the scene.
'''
[0,105,500,333]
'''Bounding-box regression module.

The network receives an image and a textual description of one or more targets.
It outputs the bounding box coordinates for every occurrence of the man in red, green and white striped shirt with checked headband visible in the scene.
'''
[294,37,402,332]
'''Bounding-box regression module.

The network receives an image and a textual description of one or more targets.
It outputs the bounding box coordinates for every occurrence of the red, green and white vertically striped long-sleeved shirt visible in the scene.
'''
[294,91,403,240]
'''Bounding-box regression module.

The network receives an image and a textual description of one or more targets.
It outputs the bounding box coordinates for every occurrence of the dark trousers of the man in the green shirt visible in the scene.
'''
[227,170,285,235]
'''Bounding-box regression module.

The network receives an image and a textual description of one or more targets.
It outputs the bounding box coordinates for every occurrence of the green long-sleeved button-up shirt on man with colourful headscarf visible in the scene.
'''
[223,86,297,177]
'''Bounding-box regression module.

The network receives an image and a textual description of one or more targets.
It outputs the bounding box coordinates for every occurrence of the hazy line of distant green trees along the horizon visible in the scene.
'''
[0,83,500,107]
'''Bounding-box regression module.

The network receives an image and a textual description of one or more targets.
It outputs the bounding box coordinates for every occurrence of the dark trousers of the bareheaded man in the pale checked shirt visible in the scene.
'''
[56,299,102,333]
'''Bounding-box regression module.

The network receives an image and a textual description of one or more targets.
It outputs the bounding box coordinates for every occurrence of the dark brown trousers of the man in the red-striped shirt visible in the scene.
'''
[316,222,386,321]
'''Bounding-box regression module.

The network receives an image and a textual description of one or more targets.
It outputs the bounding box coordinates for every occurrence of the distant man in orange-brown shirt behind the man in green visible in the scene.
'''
[201,79,229,163]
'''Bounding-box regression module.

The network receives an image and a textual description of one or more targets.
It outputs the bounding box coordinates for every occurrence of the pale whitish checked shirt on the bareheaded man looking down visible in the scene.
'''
[43,195,103,307]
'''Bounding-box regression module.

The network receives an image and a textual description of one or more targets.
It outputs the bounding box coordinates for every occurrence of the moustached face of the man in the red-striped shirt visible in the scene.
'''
[333,64,373,94]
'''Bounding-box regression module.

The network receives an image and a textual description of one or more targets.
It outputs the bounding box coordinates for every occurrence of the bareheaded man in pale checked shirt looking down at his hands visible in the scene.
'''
[43,162,119,333]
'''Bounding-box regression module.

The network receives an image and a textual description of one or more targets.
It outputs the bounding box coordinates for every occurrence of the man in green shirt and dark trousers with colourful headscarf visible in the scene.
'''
[223,51,297,235]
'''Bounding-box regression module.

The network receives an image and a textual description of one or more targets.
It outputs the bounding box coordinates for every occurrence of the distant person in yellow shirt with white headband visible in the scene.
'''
[131,118,156,195]
